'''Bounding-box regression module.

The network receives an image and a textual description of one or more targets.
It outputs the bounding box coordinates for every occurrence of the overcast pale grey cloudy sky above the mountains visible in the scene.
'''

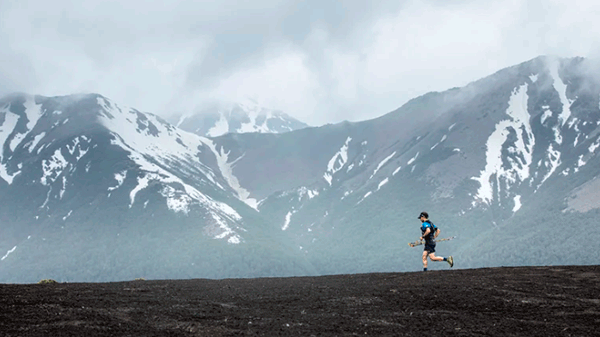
[0,0,600,125]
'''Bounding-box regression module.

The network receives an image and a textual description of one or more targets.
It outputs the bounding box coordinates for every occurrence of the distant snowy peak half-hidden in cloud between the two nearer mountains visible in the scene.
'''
[167,99,308,137]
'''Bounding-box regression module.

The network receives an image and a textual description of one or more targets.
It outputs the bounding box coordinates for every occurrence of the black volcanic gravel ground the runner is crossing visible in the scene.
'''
[0,266,600,337]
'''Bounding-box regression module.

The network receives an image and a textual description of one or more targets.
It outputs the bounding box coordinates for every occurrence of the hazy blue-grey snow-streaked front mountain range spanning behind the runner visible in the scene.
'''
[0,56,600,282]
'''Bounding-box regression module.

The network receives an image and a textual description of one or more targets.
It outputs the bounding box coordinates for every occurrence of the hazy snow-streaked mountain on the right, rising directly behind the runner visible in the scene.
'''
[204,57,600,273]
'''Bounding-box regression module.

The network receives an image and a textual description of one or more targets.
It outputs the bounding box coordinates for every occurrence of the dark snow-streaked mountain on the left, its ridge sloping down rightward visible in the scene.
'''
[0,94,316,278]
